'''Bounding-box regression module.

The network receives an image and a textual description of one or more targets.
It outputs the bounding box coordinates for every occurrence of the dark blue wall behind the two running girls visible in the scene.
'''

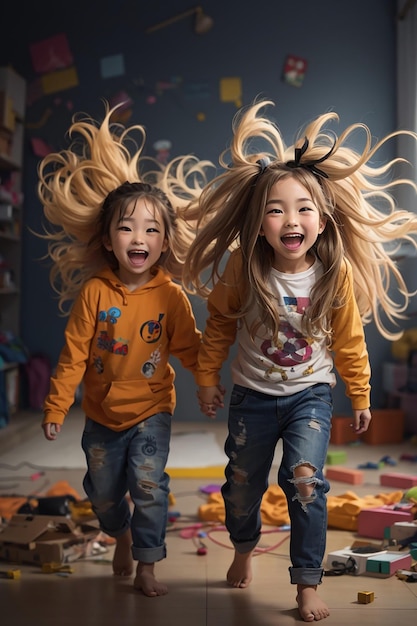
[0,0,404,420]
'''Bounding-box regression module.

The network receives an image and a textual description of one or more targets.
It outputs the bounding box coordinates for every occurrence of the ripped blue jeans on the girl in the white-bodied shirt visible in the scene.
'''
[222,384,332,585]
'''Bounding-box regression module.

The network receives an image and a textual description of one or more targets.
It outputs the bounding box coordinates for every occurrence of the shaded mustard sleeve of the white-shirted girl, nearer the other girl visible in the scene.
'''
[196,253,241,387]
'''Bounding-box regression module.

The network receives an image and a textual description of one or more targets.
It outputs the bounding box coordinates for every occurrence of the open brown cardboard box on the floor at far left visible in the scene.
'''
[0,514,100,565]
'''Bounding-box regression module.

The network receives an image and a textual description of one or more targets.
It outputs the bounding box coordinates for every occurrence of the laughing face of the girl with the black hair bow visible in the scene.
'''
[260,177,326,273]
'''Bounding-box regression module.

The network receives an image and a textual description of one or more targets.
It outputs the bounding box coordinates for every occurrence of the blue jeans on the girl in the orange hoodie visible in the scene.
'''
[82,413,171,563]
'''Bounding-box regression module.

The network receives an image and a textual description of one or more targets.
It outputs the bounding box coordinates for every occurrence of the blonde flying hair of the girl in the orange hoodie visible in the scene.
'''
[35,101,214,315]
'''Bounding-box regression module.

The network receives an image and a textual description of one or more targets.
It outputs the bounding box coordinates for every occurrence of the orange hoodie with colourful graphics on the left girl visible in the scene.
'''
[43,269,201,431]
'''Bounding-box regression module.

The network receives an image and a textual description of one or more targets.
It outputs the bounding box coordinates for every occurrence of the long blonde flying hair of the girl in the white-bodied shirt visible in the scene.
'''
[183,100,417,342]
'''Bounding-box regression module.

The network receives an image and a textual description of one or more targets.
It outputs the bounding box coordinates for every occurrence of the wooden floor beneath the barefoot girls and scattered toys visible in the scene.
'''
[0,414,417,626]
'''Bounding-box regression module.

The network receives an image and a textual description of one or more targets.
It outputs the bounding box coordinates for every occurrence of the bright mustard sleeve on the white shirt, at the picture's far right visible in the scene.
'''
[331,262,371,410]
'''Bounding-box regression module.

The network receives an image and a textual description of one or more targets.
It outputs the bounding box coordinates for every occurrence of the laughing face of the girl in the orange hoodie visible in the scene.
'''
[103,198,168,289]
